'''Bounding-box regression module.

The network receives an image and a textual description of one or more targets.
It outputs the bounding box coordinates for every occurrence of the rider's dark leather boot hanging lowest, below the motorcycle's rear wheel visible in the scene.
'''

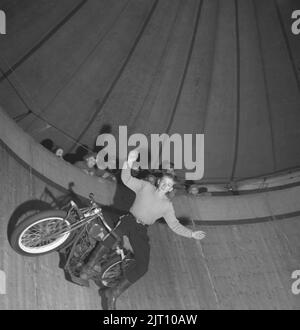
[99,277,132,310]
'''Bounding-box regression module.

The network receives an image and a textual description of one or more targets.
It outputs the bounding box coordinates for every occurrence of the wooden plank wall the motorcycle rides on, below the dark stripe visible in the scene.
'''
[0,142,300,310]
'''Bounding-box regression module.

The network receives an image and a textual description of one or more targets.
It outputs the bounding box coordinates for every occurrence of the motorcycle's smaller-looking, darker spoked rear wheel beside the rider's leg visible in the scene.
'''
[100,256,134,288]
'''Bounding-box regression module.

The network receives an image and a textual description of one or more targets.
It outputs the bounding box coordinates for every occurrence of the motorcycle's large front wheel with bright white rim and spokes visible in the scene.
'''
[10,210,72,256]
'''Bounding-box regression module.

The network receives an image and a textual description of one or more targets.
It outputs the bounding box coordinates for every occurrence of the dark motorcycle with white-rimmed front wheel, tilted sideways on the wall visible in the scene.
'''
[9,193,134,289]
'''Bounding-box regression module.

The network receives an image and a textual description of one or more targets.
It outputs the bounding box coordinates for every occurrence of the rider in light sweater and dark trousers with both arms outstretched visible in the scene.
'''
[100,150,205,310]
